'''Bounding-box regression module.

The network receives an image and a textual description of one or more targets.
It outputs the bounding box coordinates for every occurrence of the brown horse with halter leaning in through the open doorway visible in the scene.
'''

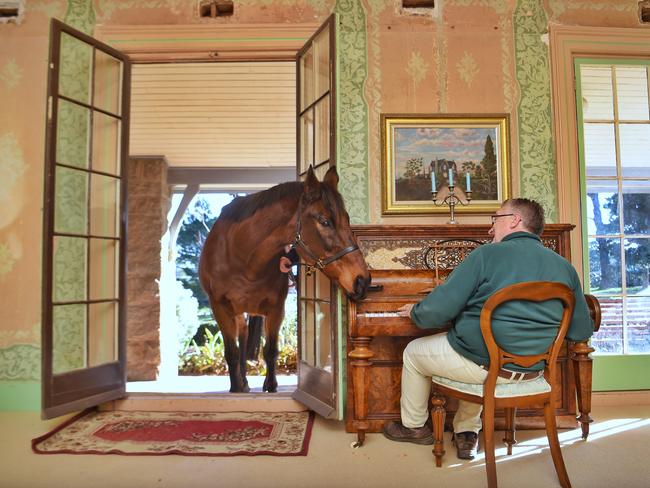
[199,167,370,392]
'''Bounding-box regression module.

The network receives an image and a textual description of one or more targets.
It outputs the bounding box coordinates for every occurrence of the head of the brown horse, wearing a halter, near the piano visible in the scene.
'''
[296,166,370,300]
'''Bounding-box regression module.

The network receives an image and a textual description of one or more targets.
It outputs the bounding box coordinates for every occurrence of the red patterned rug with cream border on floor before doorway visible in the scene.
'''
[32,410,314,456]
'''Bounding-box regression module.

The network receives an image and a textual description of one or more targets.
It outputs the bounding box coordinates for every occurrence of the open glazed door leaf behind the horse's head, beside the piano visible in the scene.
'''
[293,15,340,418]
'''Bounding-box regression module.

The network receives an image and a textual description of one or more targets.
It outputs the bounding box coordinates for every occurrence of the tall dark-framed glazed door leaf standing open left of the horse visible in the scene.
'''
[42,19,131,418]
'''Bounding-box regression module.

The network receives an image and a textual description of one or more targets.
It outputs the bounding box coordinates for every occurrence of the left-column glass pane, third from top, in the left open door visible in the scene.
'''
[54,166,88,234]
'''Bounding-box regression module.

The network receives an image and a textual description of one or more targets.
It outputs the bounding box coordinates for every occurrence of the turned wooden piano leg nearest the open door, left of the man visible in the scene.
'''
[348,337,375,447]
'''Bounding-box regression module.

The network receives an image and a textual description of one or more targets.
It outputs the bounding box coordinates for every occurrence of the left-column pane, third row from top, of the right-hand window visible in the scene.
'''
[587,180,619,235]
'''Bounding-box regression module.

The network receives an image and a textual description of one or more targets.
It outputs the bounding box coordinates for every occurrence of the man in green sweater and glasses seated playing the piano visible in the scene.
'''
[384,198,593,459]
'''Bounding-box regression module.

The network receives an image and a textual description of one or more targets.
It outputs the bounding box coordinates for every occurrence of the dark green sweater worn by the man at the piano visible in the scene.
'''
[411,232,593,371]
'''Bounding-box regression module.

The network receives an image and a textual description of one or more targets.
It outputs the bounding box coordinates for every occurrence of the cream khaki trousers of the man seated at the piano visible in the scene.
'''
[400,332,511,433]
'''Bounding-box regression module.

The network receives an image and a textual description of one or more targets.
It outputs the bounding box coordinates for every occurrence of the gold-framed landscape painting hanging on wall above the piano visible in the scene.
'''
[381,114,510,215]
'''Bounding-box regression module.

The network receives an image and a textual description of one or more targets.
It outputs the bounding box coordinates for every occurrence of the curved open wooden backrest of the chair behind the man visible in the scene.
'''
[481,281,575,389]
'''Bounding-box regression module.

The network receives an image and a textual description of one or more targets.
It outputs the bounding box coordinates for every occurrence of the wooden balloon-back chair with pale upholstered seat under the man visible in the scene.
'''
[431,281,575,488]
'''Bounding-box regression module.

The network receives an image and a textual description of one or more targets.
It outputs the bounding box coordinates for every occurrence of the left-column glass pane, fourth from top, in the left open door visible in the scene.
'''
[52,236,87,302]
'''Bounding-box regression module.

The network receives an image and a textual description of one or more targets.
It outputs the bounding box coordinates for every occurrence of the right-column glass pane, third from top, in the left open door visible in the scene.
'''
[90,174,120,237]
